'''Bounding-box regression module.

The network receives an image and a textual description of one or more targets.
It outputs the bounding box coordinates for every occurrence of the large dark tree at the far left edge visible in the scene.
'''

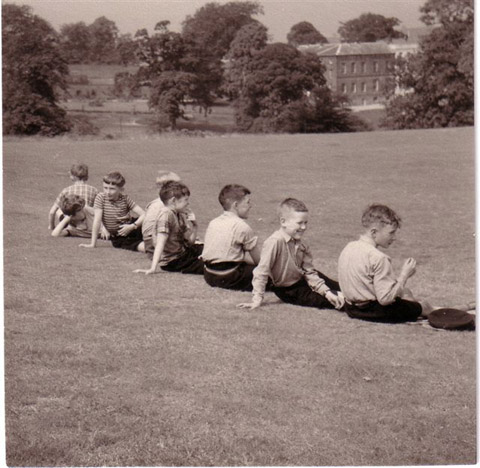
[2,3,71,136]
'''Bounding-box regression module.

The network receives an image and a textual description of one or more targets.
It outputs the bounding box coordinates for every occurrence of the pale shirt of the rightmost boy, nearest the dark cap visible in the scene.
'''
[338,235,403,305]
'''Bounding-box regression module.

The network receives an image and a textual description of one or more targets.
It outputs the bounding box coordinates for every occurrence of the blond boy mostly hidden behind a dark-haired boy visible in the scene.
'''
[142,171,197,255]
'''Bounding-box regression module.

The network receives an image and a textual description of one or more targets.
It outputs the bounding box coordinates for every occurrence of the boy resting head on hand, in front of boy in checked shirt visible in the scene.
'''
[52,194,94,237]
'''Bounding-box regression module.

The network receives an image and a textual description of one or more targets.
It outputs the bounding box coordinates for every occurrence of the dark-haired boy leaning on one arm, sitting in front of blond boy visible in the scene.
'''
[134,181,203,275]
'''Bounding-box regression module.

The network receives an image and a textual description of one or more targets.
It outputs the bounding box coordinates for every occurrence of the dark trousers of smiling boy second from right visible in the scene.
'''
[272,272,343,310]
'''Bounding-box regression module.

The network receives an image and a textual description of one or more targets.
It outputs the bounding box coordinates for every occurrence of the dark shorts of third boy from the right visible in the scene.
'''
[203,262,255,291]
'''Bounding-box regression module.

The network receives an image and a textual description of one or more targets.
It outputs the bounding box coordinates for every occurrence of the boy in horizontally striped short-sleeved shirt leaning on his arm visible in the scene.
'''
[80,172,145,252]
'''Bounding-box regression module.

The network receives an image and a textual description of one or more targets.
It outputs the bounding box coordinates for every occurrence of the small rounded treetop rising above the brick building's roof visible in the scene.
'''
[338,13,406,42]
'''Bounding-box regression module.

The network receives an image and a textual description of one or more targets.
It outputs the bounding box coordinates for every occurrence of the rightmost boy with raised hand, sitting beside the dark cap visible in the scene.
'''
[338,205,475,323]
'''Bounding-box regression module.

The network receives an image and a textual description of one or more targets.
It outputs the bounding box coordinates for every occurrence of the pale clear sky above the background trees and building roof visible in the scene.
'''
[3,0,426,42]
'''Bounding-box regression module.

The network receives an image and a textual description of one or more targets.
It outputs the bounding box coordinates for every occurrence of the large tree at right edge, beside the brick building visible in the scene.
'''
[384,0,474,129]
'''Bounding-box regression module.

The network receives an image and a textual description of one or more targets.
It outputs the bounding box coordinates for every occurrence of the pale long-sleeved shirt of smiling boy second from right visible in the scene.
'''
[252,229,330,302]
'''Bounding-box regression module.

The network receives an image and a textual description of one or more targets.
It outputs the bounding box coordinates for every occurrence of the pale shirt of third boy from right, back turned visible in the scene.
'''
[202,211,258,263]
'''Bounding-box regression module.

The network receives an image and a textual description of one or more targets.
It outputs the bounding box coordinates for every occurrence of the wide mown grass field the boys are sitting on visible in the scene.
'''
[3,128,476,466]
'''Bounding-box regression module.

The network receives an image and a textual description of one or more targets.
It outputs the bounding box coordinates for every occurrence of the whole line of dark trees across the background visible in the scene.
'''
[2,0,473,135]
